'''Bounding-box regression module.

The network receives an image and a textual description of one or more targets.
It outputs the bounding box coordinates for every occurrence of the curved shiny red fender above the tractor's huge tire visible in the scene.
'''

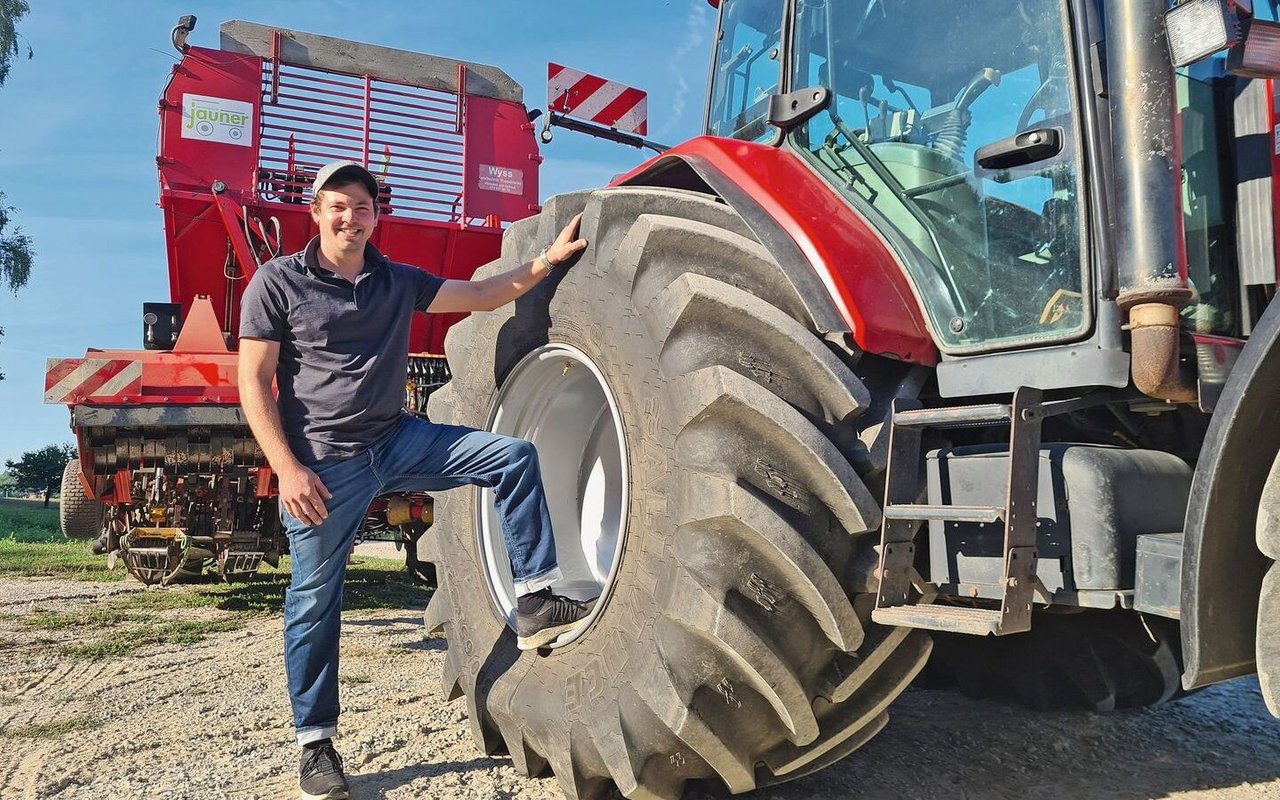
[613,136,938,366]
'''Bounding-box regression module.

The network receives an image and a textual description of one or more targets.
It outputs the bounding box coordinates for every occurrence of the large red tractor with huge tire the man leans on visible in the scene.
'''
[420,0,1280,799]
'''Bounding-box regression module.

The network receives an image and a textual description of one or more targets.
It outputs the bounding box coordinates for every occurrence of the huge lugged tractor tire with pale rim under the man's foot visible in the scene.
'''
[424,188,929,799]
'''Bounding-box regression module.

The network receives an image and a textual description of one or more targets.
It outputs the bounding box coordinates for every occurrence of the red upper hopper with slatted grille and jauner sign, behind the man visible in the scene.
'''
[156,37,540,366]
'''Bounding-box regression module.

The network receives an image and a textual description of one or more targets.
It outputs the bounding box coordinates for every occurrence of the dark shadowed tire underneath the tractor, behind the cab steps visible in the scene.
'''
[924,609,1184,712]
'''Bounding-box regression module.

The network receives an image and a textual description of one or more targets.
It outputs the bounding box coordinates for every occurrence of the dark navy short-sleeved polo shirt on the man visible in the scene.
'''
[239,237,444,465]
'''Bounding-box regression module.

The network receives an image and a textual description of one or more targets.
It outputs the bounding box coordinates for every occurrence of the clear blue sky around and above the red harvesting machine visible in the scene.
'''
[0,0,714,465]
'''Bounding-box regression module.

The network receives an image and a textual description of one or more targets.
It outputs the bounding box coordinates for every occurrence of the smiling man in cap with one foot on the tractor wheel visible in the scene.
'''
[239,161,594,800]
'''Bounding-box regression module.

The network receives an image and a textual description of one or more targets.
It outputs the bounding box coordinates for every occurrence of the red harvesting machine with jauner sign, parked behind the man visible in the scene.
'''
[45,17,540,584]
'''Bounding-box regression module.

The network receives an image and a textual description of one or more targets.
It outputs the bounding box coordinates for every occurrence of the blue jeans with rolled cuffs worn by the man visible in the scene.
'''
[280,415,561,745]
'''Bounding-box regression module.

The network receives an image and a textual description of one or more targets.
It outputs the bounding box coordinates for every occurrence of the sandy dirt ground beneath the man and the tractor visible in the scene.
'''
[0,579,1280,800]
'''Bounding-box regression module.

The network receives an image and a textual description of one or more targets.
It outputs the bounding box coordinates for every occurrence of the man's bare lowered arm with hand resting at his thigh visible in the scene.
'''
[237,337,333,525]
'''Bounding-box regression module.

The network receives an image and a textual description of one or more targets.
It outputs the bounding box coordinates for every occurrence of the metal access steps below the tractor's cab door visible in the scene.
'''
[872,387,1044,636]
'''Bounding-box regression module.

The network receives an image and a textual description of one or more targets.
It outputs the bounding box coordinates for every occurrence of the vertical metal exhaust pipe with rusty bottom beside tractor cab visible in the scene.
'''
[1106,0,1198,403]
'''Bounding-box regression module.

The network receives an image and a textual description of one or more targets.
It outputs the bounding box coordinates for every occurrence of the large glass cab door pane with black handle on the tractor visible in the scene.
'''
[791,0,1091,352]
